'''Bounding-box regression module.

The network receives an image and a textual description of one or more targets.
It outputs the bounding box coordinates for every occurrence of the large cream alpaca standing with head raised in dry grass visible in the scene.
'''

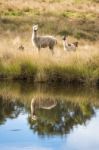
[32,25,57,54]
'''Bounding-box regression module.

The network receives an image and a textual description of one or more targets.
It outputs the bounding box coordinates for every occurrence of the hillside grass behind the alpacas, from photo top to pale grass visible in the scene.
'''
[0,0,99,41]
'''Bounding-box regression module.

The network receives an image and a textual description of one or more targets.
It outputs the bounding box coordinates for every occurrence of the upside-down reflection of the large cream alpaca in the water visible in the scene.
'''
[31,98,57,120]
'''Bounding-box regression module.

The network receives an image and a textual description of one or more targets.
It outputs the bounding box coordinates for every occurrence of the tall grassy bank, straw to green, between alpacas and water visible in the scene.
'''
[0,49,99,84]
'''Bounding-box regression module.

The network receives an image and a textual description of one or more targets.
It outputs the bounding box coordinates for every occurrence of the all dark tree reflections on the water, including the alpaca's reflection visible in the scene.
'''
[0,90,94,135]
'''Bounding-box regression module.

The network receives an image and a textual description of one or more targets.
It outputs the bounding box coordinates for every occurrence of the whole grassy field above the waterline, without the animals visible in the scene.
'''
[0,0,99,85]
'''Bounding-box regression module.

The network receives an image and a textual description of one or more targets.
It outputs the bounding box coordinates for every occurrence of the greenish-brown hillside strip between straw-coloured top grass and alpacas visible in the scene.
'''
[0,10,99,41]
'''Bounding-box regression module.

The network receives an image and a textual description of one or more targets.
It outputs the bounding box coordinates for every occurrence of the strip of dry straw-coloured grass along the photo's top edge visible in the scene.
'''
[0,0,99,12]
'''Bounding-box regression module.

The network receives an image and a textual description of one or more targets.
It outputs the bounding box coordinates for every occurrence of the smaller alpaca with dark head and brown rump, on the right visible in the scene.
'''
[63,36,78,51]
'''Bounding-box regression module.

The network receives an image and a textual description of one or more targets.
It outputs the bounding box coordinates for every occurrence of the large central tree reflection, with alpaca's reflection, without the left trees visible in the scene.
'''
[28,98,94,135]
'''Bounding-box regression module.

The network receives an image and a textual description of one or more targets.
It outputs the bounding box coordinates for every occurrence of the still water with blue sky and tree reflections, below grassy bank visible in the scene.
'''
[0,82,99,150]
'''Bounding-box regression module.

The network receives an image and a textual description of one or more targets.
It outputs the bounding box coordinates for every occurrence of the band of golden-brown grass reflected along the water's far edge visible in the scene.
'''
[0,82,99,108]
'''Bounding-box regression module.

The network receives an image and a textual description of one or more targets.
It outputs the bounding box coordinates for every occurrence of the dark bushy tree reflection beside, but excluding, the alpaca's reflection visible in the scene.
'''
[28,100,94,135]
